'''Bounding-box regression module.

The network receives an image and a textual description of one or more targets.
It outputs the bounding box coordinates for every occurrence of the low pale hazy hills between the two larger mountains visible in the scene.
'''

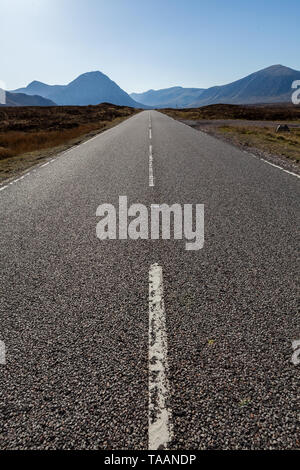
[130,86,204,108]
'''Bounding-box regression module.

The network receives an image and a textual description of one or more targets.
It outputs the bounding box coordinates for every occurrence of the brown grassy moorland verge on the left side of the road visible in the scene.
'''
[0,103,138,182]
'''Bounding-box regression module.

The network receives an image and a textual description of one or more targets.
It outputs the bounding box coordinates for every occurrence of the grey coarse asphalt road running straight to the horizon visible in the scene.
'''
[0,111,300,450]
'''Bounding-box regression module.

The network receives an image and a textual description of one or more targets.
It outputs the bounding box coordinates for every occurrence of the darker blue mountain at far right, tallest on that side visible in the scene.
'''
[189,65,300,107]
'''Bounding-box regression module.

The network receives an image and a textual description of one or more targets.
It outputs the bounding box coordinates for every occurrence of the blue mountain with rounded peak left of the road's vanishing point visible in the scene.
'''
[15,72,145,108]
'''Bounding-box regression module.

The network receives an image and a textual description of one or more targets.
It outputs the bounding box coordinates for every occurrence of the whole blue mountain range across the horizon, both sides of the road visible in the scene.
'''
[7,65,300,109]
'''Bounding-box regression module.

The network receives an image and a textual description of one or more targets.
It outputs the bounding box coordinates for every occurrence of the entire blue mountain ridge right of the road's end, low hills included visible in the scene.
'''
[130,65,300,108]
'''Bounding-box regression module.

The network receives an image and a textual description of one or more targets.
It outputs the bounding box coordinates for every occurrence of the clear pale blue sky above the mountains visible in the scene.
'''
[0,0,300,93]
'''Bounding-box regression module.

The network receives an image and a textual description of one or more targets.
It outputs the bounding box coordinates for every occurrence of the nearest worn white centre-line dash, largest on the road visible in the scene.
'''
[148,264,173,450]
